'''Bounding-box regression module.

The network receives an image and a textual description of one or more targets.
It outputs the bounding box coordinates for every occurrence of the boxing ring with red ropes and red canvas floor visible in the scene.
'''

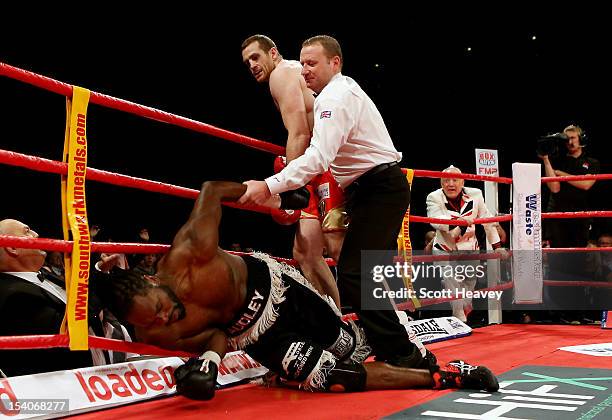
[0,63,612,419]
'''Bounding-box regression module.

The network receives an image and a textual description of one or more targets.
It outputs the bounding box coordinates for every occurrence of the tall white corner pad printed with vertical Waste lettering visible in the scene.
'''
[512,163,543,304]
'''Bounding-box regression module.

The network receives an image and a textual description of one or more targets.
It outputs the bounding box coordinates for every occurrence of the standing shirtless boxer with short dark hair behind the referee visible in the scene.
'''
[241,35,346,307]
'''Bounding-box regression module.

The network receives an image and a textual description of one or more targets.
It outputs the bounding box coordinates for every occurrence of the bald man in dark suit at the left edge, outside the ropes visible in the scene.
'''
[0,219,100,376]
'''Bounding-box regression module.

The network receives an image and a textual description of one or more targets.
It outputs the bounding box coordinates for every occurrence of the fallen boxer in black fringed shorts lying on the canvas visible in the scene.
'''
[103,181,499,400]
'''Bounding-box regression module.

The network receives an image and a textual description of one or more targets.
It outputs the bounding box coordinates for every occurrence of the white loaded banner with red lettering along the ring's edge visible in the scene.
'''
[0,351,267,419]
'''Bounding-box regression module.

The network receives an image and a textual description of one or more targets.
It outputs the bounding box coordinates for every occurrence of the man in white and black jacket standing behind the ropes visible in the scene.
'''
[427,165,507,322]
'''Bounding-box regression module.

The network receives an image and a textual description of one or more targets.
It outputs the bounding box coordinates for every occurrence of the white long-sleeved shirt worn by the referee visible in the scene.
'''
[265,73,402,194]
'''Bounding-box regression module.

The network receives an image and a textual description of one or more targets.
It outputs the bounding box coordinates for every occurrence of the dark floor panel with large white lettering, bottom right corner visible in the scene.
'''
[384,366,612,420]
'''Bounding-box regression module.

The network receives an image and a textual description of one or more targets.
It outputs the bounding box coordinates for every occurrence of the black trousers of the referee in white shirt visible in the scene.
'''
[338,165,416,360]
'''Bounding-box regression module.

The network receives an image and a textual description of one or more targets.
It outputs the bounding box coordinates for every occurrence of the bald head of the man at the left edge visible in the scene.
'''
[0,219,46,272]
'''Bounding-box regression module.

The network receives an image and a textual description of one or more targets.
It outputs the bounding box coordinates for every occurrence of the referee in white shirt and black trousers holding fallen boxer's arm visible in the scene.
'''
[240,35,430,367]
